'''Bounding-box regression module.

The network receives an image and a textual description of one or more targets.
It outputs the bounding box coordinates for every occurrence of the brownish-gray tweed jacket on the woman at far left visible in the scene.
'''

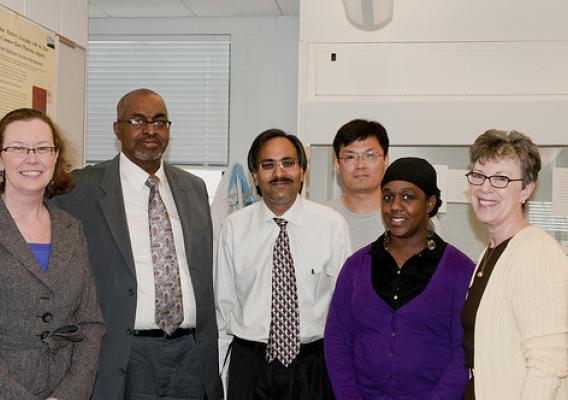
[0,200,104,400]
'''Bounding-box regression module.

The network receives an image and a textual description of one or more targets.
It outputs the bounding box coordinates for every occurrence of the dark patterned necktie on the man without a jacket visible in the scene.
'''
[266,218,300,367]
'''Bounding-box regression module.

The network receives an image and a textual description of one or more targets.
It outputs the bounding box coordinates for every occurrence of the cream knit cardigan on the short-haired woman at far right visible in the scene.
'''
[474,225,568,400]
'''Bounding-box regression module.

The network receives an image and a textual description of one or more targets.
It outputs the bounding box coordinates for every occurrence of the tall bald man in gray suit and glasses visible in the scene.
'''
[56,89,222,400]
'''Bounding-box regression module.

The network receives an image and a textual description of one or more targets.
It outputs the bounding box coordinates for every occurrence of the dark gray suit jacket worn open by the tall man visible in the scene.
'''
[56,155,222,400]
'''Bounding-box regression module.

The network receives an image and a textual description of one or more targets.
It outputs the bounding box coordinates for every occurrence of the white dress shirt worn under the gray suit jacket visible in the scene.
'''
[119,153,196,329]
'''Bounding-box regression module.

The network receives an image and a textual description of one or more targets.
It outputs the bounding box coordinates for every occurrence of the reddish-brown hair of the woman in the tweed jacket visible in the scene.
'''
[0,108,75,198]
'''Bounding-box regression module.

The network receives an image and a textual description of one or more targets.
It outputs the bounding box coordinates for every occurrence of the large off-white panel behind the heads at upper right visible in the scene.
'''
[298,0,568,145]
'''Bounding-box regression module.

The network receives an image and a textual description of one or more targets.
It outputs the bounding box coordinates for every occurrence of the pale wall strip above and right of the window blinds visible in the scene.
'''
[89,17,298,165]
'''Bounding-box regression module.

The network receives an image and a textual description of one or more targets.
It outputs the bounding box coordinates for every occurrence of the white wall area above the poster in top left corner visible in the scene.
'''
[0,0,88,47]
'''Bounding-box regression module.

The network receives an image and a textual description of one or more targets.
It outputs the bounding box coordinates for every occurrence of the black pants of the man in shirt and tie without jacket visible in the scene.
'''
[227,338,334,400]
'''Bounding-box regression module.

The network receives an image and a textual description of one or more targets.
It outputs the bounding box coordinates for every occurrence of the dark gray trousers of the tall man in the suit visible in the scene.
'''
[124,334,204,400]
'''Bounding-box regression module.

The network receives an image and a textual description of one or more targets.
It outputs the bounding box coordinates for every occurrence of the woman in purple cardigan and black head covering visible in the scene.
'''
[324,157,474,400]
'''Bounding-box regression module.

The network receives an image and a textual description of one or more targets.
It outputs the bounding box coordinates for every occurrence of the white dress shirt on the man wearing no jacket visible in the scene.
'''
[213,196,351,361]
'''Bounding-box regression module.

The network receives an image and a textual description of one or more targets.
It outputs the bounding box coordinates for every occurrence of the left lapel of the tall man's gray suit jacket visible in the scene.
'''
[99,155,136,277]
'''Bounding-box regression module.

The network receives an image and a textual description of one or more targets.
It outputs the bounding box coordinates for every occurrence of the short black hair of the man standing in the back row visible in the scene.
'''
[333,119,389,157]
